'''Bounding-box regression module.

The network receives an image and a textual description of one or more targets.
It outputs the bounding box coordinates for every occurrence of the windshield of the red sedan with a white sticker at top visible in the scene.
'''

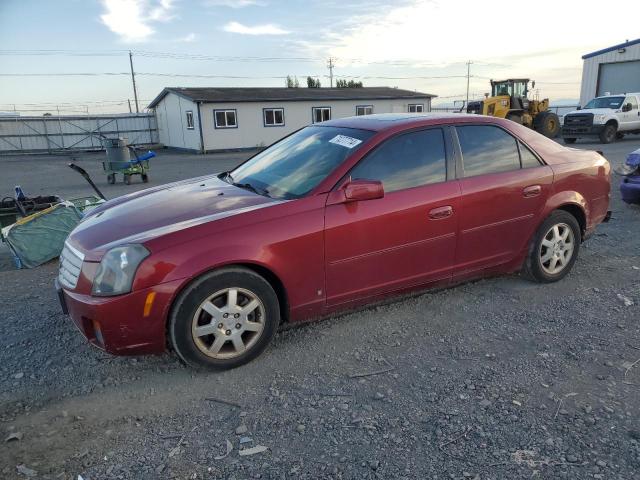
[226,126,374,199]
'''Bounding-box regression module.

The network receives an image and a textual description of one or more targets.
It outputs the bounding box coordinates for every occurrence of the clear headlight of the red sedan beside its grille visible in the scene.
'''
[91,245,149,297]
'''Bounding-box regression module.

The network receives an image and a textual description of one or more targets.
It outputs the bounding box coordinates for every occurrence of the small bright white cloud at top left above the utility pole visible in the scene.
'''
[100,0,174,42]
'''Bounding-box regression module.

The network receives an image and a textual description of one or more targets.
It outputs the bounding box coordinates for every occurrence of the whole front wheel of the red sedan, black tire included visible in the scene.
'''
[168,267,280,370]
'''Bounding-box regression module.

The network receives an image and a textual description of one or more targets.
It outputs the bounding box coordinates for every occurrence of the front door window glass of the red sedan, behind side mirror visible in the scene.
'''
[351,128,447,193]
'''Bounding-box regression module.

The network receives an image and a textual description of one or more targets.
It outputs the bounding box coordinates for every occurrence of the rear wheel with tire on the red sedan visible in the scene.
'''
[524,210,582,283]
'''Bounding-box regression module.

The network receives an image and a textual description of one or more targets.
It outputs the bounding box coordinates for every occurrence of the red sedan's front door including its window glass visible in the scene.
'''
[325,128,460,306]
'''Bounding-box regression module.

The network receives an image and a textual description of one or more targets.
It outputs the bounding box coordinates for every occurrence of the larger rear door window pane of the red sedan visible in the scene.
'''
[456,125,520,177]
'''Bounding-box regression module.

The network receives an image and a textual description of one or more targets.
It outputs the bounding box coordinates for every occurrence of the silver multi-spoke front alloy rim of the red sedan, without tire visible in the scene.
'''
[191,288,265,359]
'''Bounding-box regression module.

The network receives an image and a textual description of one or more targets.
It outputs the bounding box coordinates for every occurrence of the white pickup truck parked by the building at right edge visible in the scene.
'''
[562,93,640,143]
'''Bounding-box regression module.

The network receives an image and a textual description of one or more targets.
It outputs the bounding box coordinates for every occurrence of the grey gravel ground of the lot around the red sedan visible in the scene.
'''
[0,138,640,480]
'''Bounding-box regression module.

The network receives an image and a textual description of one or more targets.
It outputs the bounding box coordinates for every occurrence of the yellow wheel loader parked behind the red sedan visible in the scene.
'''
[467,78,560,138]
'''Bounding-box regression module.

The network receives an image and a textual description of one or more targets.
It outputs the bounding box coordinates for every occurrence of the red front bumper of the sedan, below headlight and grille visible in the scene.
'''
[56,279,182,355]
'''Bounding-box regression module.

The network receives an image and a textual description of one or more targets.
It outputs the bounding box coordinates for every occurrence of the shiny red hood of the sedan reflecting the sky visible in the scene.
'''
[69,175,280,260]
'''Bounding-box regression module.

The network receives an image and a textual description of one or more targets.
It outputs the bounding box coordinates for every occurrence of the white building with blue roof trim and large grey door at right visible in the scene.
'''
[580,38,640,105]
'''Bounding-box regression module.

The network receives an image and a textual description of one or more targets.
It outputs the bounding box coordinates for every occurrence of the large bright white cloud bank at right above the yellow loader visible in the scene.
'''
[295,0,640,100]
